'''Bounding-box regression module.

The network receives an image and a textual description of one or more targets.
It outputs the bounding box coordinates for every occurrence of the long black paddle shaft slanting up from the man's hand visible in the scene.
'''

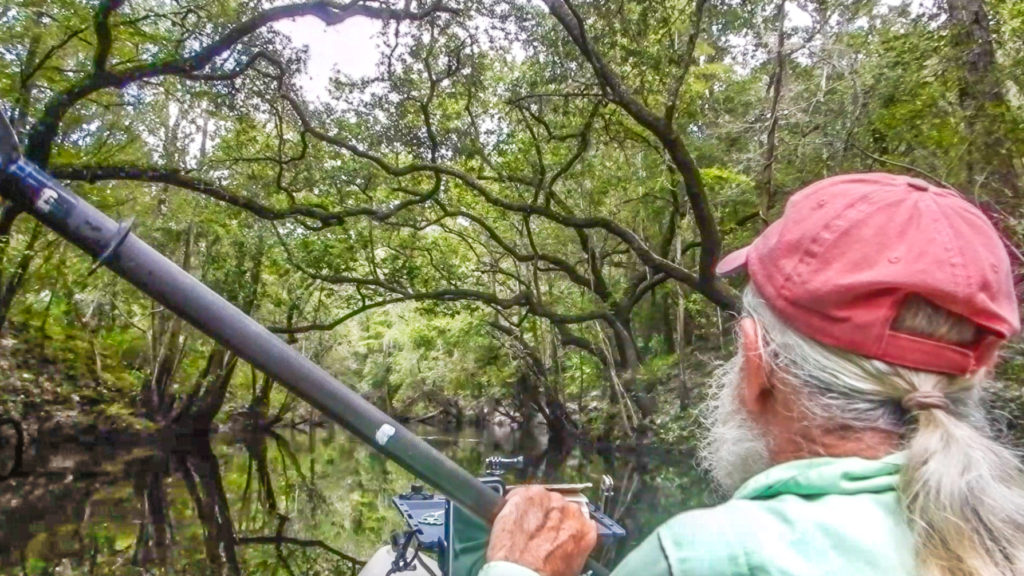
[0,114,607,575]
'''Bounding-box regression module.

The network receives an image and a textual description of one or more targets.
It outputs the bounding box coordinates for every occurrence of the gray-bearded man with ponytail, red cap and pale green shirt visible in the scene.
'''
[480,174,1024,576]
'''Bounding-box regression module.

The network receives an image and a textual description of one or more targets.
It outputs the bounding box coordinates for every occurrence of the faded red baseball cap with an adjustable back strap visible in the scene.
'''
[716,173,1020,375]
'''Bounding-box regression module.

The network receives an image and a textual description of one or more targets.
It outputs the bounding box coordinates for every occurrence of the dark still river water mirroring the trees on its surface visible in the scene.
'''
[0,427,711,576]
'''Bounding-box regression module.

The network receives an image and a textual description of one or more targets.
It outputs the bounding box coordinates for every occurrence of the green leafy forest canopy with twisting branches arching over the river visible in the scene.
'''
[0,0,1024,436]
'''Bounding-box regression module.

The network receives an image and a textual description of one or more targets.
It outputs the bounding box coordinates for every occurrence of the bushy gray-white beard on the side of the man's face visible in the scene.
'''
[698,354,772,495]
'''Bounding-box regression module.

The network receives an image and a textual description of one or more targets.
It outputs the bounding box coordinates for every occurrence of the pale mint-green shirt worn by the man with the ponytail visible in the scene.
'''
[479,454,915,576]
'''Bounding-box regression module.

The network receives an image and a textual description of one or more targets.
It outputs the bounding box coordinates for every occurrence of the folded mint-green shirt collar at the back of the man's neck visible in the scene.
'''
[732,452,906,500]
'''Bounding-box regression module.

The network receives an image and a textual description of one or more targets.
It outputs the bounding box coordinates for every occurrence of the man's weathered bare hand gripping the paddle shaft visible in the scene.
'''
[487,486,597,576]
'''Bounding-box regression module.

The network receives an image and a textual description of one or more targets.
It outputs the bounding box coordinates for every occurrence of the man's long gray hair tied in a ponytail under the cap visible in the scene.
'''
[743,285,1024,576]
